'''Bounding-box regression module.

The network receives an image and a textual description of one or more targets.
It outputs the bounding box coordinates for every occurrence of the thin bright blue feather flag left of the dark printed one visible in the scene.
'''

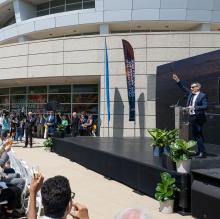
[105,42,111,126]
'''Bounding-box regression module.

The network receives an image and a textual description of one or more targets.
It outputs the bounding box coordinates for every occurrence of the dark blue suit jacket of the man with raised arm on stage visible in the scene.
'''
[177,81,208,118]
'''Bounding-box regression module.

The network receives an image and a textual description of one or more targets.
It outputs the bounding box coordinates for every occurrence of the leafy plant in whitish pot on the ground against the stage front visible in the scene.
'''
[155,172,179,214]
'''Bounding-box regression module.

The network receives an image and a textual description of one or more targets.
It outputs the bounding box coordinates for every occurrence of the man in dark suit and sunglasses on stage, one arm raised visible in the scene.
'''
[173,74,208,158]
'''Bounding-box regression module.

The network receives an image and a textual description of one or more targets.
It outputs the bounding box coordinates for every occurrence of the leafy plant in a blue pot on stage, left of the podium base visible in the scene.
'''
[148,128,178,157]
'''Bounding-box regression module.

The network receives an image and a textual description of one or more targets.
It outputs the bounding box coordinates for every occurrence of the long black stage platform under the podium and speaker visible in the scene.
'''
[53,137,220,211]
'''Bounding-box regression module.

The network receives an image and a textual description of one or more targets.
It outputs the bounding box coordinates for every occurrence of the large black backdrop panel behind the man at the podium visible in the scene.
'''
[156,50,220,145]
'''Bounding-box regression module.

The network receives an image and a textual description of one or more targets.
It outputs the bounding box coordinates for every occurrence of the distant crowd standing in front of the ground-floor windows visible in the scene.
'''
[0,110,97,147]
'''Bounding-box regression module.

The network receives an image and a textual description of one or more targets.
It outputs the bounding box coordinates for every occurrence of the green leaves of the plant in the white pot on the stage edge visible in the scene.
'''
[170,139,196,162]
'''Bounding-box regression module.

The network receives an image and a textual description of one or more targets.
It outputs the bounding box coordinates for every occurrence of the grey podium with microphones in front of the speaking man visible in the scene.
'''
[174,106,190,141]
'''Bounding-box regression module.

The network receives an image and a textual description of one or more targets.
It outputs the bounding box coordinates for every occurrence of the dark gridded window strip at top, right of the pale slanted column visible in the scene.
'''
[37,0,95,17]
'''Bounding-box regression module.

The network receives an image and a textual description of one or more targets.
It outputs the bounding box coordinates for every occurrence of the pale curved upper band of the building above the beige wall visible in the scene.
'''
[0,0,220,43]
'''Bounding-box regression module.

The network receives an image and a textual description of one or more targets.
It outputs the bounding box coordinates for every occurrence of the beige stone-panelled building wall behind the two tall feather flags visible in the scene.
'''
[0,32,220,136]
